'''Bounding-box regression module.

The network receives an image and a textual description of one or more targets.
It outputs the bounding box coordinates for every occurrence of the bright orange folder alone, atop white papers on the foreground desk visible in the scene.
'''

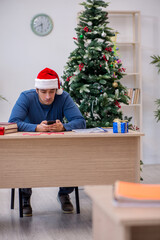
[114,181,160,202]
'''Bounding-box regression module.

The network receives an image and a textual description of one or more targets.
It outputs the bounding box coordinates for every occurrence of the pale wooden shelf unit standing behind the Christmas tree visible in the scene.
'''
[108,11,142,131]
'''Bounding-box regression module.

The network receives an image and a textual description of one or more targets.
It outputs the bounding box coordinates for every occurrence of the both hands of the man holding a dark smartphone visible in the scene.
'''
[36,120,65,132]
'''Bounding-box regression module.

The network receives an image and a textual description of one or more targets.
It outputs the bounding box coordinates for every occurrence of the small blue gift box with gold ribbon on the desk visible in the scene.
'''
[113,119,128,133]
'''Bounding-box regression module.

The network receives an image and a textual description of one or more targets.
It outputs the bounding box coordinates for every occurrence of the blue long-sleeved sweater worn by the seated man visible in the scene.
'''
[9,89,86,132]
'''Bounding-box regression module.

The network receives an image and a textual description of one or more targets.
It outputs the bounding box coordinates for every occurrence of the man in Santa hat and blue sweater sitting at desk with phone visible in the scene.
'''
[9,68,86,216]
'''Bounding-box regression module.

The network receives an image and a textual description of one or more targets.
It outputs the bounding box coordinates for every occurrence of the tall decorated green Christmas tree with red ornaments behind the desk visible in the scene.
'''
[62,0,128,127]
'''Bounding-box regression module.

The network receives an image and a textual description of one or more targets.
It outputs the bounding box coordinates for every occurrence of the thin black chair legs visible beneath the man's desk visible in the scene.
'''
[11,187,80,218]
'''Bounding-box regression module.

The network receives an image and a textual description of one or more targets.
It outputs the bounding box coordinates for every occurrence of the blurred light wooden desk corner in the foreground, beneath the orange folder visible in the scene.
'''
[85,186,160,240]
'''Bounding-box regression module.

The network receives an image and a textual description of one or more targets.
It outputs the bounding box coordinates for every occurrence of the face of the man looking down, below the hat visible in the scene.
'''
[36,89,56,105]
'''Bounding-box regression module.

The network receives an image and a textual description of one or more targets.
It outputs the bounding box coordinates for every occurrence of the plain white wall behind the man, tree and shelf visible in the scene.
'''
[0,0,160,164]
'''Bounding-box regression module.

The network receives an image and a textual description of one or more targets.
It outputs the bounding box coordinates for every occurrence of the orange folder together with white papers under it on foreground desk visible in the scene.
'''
[113,181,160,207]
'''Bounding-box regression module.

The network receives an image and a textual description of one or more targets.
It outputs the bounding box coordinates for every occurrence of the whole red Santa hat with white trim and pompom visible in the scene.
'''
[35,68,63,95]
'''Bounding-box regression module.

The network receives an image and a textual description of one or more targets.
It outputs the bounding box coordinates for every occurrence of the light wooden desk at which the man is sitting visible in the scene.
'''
[0,132,143,188]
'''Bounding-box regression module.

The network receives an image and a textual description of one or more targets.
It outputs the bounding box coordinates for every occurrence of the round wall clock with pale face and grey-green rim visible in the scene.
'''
[31,14,53,36]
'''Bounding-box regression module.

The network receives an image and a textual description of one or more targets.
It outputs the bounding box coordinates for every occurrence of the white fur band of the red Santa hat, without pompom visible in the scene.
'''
[35,78,58,89]
